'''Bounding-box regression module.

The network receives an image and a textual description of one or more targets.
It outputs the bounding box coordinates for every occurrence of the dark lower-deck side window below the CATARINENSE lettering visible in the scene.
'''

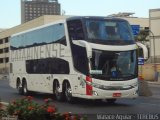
[26,58,70,74]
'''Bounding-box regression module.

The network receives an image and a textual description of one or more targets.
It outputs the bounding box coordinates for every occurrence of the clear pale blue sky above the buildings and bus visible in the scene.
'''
[0,0,160,28]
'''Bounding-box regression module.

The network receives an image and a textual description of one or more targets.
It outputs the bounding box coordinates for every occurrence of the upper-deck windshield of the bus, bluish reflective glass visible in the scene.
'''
[85,19,134,43]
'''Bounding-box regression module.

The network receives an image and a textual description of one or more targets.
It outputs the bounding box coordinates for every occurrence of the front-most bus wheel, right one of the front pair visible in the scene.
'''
[65,82,73,102]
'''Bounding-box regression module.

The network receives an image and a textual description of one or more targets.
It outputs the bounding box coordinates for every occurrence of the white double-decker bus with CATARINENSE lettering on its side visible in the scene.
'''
[10,17,138,102]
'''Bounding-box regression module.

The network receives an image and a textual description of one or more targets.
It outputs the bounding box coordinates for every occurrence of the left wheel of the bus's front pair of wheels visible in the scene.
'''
[53,80,63,101]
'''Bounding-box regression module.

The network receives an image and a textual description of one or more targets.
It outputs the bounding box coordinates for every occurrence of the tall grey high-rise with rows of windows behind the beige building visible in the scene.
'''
[21,0,61,23]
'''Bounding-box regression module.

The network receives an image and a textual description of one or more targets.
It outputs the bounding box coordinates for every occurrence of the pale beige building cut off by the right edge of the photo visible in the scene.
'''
[149,9,160,63]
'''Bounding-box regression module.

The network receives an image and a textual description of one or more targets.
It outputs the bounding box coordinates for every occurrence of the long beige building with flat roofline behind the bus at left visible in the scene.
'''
[0,15,68,74]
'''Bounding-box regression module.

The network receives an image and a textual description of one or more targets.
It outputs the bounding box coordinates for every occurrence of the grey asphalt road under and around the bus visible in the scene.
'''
[0,80,160,120]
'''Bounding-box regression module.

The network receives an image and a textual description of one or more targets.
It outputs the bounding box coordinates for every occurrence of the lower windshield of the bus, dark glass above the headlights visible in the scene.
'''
[91,49,137,80]
